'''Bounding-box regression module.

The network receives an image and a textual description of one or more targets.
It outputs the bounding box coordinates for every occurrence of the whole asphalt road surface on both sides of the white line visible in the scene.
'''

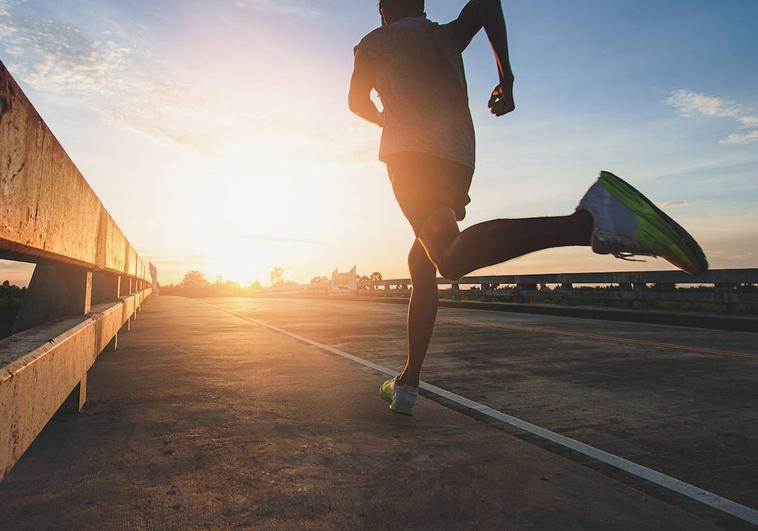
[0,297,758,529]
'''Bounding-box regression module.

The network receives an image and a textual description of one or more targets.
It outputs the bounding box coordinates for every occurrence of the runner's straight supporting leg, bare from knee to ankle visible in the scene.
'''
[398,240,438,386]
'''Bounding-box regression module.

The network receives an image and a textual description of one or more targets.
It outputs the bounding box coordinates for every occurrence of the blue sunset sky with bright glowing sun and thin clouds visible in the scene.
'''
[0,0,758,285]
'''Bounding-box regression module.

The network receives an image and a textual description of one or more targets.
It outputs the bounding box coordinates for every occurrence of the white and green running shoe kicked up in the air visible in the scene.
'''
[577,171,708,275]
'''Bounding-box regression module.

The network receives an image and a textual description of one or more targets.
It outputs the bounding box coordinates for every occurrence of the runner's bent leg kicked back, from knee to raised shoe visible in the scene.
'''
[419,171,708,280]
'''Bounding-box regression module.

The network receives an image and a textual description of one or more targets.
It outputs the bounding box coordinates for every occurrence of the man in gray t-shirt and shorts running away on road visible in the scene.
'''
[348,0,708,415]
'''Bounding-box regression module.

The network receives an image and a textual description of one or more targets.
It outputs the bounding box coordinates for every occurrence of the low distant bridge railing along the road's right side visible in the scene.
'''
[361,269,758,312]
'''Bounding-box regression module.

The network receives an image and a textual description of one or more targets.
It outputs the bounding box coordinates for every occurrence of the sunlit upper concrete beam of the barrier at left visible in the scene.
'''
[0,63,150,281]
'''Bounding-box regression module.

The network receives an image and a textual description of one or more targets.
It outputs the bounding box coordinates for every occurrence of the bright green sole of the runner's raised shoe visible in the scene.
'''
[600,171,708,275]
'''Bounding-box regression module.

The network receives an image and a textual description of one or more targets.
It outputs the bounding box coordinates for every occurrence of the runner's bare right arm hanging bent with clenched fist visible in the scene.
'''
[456,0,516,116]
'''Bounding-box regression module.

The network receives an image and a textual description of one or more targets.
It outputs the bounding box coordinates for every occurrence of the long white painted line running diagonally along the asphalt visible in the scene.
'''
[214,306,758,525]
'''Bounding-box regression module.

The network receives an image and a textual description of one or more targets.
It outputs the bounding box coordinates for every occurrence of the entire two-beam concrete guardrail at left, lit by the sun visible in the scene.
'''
[0,62,152,480]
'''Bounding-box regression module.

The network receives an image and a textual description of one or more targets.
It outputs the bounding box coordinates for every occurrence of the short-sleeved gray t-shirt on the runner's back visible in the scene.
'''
[355,17,476,168]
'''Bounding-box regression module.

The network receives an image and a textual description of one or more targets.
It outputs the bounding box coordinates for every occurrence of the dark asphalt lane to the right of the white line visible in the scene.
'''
[208,299,758,524]
